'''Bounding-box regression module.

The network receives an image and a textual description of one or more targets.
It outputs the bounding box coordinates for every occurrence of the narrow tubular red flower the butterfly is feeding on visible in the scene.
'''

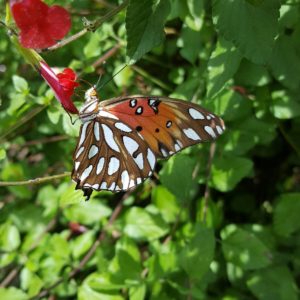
[40,61,79,114]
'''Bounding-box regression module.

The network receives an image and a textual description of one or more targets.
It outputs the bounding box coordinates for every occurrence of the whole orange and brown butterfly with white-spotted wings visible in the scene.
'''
[72,87,225,200]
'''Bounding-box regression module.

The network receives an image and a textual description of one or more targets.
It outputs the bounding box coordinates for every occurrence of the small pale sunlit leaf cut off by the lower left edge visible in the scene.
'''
[0,223,21,252]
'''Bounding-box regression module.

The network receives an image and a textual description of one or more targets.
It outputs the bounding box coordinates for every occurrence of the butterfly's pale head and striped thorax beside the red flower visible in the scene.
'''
[79,86,99,122]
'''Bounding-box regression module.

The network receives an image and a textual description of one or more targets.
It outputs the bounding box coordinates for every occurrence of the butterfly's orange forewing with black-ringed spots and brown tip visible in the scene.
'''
[100,96,225,158]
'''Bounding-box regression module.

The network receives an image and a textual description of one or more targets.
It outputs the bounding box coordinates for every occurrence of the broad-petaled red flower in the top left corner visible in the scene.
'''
[10,0,71,49]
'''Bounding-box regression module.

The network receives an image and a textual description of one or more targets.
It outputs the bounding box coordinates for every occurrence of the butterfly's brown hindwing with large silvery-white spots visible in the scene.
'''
[72,115,156,192]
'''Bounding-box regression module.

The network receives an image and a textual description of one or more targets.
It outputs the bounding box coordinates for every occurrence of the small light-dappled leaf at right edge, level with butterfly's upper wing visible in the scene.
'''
[270,90,300,120]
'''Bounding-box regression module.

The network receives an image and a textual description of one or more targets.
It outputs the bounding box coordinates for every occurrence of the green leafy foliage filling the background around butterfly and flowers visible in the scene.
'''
[0,0,300,300]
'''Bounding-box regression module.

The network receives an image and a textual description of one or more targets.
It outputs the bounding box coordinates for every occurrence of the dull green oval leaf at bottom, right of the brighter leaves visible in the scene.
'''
[180,224,215,281]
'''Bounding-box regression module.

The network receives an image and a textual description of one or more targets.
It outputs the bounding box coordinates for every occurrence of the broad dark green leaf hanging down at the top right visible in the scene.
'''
[213,0,280,64]
